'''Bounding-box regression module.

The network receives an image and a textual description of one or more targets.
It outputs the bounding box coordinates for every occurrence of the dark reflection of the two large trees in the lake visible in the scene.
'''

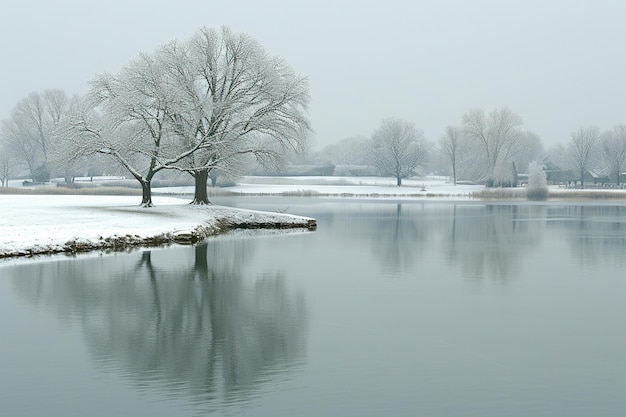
[13,239,308,410]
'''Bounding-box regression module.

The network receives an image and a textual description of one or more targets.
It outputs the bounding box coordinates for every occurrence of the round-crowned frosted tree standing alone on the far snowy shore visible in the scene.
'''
[370,118,426,187]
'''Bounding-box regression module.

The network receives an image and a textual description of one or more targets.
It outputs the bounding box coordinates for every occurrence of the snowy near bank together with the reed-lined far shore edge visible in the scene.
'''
[0,182,626,260]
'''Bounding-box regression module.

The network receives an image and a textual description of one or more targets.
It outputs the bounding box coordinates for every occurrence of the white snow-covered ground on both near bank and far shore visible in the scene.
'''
[6,173,626,258]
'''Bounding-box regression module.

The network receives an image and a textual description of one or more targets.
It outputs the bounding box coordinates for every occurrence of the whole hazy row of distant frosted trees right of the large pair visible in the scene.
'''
[317,107,626,186]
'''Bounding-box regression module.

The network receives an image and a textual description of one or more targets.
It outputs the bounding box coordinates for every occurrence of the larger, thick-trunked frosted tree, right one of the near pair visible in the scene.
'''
[168,27,310,204]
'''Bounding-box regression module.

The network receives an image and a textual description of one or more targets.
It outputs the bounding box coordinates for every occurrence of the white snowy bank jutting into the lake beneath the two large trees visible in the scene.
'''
[0,194,316,258]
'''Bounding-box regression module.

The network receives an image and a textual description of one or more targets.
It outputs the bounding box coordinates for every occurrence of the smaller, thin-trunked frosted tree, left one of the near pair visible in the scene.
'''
[60,49,197,207]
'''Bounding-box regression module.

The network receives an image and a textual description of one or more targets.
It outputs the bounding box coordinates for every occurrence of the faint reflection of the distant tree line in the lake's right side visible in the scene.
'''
[276,202,626,283]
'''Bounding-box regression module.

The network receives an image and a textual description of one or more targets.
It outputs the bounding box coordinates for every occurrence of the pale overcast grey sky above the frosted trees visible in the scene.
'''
[0,0,626,146]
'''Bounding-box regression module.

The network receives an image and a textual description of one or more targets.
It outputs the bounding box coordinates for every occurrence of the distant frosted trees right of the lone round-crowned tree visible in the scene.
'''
[438,113,626,186]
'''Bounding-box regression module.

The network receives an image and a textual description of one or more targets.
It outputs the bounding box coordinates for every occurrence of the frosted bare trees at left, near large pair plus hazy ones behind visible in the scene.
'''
[0,27,311,206]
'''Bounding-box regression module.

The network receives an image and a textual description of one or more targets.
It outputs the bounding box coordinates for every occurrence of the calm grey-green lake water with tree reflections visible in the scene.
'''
[0,198,626,417]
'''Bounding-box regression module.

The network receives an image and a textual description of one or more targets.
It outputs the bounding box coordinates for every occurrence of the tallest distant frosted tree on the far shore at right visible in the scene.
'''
[463,107,523,182]
